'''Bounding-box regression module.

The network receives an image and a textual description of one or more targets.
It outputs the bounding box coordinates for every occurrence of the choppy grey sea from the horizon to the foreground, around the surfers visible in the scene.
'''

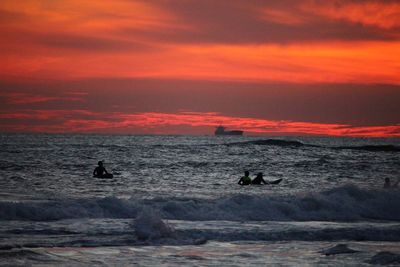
[0,134,400,266]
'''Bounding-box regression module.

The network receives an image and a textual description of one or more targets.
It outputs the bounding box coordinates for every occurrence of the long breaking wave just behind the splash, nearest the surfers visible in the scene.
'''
[0,185,400,221]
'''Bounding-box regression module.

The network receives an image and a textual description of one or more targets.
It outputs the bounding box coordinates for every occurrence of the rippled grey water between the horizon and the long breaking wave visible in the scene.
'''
[0,134,400,200]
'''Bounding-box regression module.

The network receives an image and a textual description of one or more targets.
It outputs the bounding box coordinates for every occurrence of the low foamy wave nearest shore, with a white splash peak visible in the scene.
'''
[0,220,400,251]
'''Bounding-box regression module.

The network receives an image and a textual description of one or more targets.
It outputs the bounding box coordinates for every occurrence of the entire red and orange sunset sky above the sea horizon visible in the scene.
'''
[0,0,400,137]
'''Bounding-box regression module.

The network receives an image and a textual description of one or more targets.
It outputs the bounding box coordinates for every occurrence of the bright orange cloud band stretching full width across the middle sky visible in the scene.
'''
[0,42,400,84]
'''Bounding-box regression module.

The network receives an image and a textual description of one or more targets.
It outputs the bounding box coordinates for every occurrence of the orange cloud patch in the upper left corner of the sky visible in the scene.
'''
[0,0,178,35]
